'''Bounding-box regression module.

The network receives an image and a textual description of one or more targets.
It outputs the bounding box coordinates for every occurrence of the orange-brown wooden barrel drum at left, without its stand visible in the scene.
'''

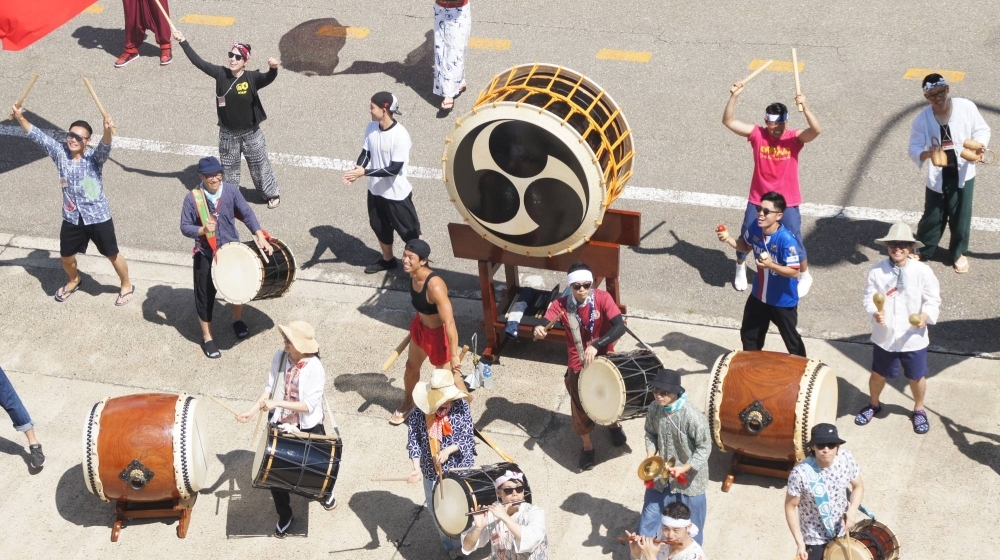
[83,393,208,502]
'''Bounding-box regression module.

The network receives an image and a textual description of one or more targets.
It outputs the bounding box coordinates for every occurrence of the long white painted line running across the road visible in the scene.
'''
[7,125,1000,232]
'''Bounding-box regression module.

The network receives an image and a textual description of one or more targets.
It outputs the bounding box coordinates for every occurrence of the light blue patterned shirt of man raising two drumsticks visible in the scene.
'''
[28,126,111,226]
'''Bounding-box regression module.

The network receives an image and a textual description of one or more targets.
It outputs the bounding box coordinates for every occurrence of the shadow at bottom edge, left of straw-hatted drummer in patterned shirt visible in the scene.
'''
[346,490,424,560]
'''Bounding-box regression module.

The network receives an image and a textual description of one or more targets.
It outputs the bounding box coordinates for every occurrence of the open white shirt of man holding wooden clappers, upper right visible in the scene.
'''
[909,97,990,193]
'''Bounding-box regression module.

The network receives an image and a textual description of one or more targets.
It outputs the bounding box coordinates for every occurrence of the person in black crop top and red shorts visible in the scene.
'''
[389,239,469,425]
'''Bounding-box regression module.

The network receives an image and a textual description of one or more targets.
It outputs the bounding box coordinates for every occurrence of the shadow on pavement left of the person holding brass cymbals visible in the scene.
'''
[559,492,641,560]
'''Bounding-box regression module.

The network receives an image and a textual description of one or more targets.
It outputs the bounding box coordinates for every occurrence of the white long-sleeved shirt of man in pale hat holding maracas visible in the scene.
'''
[862,259,941,352]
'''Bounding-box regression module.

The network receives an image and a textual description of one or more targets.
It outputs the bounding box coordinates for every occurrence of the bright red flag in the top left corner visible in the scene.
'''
[0,0,96,51]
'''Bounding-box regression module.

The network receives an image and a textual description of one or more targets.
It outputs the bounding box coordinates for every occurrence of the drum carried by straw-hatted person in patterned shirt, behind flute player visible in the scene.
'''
[434,463,531,539]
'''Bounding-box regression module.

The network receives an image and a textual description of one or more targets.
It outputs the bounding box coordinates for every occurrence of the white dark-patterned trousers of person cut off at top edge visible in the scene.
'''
[434,4,472,97]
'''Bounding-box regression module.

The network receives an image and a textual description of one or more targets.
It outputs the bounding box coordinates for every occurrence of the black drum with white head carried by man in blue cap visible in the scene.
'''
[212,237,295,305]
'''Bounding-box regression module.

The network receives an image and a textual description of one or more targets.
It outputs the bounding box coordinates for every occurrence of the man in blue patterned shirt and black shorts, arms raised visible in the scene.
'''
[10,105,135,306]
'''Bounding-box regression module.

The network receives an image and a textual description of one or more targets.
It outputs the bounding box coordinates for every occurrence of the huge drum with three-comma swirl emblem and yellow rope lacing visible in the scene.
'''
[443,64,635,256]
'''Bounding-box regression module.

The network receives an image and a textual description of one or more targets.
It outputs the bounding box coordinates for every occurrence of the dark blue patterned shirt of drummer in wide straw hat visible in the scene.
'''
[406,399,476,480]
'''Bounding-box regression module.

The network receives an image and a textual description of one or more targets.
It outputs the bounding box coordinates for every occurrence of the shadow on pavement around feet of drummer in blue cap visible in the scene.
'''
[142,285,274,350]
